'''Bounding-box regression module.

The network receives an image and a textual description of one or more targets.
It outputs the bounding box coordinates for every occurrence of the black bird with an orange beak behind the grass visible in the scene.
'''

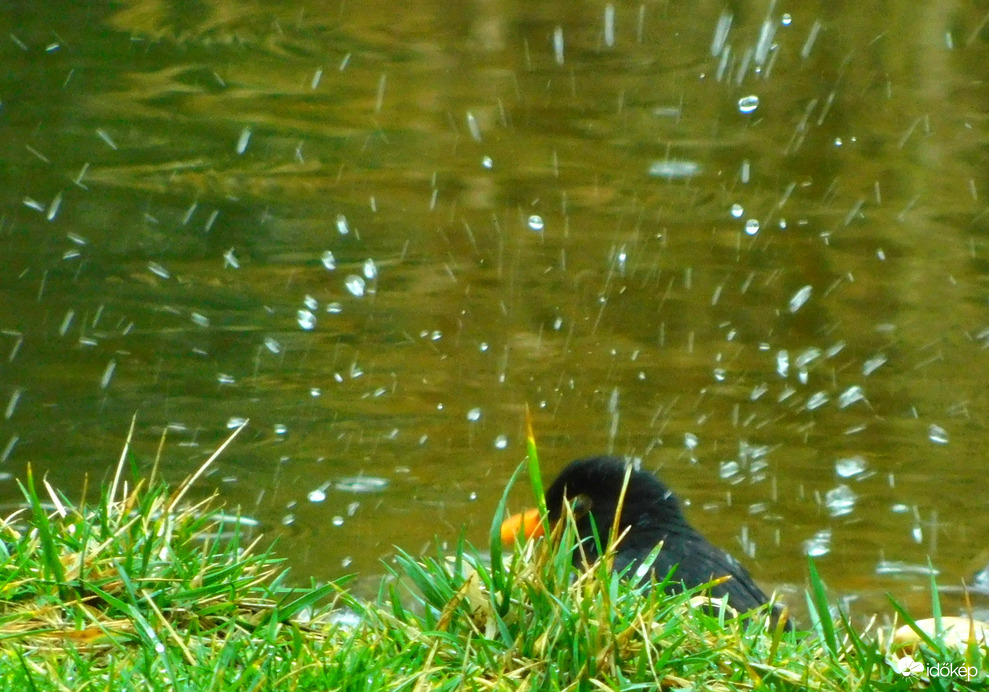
[502,456,789,627]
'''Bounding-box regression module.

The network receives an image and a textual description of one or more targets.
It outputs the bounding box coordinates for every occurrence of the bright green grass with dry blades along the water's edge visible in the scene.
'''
[0,430,989,691]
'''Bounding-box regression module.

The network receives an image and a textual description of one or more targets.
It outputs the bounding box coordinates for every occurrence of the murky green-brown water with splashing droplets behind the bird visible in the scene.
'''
[0,0,989,624]
